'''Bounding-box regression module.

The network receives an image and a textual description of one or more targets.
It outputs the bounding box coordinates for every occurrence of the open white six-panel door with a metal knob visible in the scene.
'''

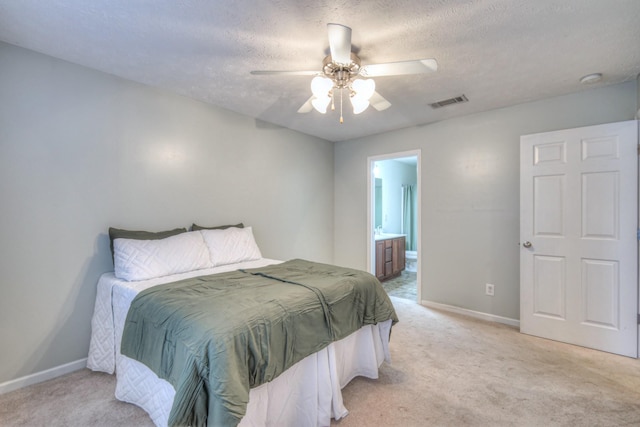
[520,121,638,357]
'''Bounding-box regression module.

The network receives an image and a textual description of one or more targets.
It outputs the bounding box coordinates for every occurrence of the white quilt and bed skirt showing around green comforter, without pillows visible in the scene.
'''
[87,258,391,426]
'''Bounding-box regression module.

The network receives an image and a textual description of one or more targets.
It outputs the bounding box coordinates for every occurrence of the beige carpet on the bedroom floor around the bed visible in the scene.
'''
[0,298,640,427]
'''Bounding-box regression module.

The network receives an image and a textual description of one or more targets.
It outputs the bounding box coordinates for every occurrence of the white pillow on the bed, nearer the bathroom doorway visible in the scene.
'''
[200,227,262,267]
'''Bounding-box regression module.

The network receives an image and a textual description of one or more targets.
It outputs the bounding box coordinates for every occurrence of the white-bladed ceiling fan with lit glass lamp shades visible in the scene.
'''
[251,24,438,123]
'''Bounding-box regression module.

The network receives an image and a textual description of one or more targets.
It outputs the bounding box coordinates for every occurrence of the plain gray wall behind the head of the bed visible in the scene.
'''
[0,43,333,383]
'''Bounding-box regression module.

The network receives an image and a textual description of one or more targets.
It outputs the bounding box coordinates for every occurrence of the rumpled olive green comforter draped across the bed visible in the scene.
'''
[121,260,398,426]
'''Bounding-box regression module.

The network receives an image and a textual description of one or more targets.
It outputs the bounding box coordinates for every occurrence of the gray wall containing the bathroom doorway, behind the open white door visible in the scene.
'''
[334,81,638,319]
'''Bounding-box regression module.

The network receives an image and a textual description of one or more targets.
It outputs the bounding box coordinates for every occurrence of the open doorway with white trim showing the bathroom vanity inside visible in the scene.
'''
[367,150,422,302]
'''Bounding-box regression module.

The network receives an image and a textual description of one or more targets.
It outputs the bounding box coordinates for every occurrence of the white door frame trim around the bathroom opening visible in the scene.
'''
[367,149,422,303]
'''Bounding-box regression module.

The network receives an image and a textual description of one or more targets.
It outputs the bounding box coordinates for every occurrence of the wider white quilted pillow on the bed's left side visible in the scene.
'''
[113,231,212,281]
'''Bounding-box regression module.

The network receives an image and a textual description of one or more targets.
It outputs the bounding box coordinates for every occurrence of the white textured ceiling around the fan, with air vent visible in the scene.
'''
[0,0,640,141]
